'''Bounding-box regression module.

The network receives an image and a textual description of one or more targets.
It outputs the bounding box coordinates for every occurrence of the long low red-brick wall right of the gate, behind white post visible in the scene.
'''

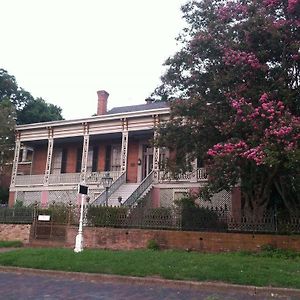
[66,227,300,252]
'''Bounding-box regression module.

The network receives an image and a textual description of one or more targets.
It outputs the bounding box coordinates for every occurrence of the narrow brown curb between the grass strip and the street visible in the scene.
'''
[0,266,300,299]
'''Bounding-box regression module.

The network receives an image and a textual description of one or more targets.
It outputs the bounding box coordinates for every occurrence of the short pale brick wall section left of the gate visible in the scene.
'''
[0,224,31,244]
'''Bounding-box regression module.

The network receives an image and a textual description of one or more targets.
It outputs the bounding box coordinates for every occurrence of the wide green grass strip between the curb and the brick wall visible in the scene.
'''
[0,248,300,289]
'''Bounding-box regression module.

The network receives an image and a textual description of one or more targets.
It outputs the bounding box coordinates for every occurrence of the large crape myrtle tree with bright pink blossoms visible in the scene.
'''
[154,0,300,217]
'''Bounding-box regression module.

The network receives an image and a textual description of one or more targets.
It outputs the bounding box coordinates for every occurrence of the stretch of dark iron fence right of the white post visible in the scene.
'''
[87,206,300,234]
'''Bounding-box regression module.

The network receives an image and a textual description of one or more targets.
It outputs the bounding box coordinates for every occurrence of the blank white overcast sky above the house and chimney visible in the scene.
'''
[0,0,186,119]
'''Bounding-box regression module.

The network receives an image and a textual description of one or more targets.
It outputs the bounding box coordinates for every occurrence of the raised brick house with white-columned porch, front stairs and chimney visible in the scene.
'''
[9,90,231,207]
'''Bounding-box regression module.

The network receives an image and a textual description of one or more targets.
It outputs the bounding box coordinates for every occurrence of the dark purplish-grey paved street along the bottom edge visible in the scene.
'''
[0,272,299,300]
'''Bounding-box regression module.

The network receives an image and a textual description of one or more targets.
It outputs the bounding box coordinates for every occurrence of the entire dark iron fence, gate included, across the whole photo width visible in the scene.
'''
[0,203,300,236]
